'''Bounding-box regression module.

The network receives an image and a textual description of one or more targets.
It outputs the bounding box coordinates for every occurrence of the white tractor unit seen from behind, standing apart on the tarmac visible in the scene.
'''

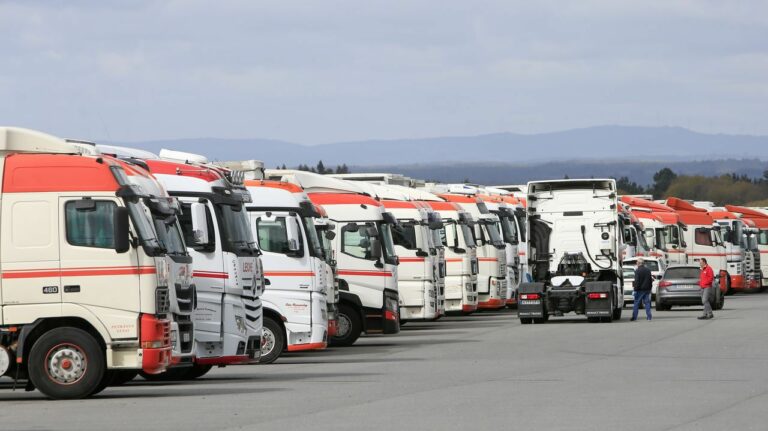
[517,179,630,324]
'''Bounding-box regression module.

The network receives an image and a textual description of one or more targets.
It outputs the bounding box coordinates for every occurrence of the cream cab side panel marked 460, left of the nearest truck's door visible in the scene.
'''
[0,193,61,322]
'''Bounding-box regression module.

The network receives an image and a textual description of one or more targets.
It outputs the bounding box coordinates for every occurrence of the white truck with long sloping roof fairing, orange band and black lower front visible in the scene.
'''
[265,169,400,346]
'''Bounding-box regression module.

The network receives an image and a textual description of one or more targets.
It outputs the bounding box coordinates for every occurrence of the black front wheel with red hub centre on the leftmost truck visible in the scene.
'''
[28,327,106,399]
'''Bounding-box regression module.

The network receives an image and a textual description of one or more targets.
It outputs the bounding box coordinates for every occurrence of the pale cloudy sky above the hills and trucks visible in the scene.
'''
[0,0,768,144]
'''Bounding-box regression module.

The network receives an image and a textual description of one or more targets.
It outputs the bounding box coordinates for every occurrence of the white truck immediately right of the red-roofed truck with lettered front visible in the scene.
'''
[245,180,333,363]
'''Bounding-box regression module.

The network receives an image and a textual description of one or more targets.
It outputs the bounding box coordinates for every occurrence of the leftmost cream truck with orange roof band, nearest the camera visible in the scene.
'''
[0,127,172,399]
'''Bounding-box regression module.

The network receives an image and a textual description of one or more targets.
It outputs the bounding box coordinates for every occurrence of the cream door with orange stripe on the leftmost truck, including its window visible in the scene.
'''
[59,196,141,318]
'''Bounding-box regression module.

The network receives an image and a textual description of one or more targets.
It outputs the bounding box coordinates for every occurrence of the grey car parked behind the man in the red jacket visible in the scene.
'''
[656,265,725,311]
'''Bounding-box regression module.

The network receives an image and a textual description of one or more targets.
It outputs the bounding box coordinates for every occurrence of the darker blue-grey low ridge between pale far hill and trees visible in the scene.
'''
[350,158,768,186]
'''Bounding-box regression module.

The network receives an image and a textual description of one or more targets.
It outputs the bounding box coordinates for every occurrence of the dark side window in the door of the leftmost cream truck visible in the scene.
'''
[64,201,117,248]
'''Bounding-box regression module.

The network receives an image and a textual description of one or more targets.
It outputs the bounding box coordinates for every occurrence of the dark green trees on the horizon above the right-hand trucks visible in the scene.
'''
[616,168,768,206]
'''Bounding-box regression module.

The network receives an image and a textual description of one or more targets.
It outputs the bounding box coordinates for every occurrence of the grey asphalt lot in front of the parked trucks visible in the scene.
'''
[0,294,768,431]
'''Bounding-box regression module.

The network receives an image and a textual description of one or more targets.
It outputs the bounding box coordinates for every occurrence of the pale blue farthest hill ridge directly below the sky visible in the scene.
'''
[118,126,768,168]
